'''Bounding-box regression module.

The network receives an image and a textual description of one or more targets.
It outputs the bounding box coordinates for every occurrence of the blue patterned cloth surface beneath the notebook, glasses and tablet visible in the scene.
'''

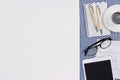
[79,0,120,80]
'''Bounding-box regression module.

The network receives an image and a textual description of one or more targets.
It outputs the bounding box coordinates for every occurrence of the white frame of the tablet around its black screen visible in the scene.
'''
[82,56,115,80]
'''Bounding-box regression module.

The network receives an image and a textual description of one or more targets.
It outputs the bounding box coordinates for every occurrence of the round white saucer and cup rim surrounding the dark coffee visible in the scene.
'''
[103,5,120,32]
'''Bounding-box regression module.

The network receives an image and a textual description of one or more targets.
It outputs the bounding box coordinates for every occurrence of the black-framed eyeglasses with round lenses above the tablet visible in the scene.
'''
[84,37,112,56]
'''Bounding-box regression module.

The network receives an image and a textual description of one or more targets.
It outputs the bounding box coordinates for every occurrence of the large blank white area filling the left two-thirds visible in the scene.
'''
[0,0,79,80]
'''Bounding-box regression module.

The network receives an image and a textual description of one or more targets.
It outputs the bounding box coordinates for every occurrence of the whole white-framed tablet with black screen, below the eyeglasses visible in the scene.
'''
[83,57,115,80]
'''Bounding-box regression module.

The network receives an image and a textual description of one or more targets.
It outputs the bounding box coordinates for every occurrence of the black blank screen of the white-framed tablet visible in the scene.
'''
[84,60,113,80]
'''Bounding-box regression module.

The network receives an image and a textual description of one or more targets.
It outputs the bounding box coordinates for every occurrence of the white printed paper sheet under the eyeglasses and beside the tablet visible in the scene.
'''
[96,41,120,79]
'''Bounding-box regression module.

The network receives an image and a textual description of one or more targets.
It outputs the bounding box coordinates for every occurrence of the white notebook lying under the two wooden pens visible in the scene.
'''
[84,2,110,37]
